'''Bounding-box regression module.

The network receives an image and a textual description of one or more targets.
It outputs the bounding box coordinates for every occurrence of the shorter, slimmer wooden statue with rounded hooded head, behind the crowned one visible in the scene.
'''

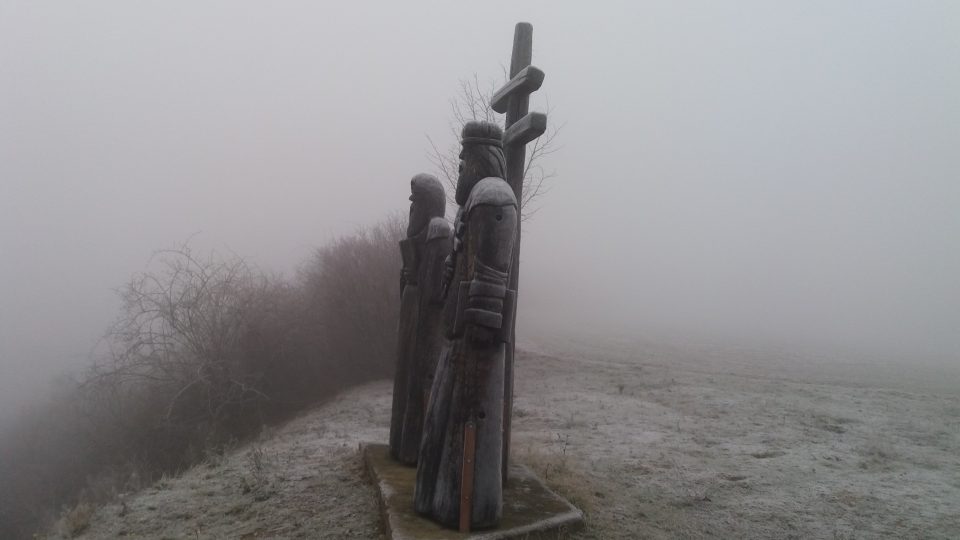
[390,174,451,465]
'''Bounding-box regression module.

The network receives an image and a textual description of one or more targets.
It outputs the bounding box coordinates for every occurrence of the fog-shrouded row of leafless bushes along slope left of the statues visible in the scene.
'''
[0,218,404,538]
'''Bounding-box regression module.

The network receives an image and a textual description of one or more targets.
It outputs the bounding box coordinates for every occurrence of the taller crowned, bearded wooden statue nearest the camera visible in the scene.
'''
[414,122,519,531]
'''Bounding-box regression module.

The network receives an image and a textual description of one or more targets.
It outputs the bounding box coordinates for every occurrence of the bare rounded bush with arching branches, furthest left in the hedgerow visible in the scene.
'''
[84,246,267,460]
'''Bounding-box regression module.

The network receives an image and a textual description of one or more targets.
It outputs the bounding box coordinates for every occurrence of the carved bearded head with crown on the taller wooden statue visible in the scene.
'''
[457,121,507,205]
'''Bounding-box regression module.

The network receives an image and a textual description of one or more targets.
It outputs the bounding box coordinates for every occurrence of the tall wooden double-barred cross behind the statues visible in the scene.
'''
[490,23,547,485]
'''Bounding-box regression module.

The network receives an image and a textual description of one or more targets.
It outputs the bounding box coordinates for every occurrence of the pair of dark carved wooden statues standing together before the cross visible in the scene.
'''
[390,122,519,530]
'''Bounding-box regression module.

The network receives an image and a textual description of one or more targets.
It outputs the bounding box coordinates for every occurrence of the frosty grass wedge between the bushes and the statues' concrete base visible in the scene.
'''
[70,382,391,539]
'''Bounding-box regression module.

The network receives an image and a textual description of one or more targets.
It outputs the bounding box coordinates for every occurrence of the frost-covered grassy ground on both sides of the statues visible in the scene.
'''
[71,340,960,538]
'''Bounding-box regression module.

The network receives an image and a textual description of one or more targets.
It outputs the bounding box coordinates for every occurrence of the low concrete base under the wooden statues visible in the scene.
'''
[360,443,583,540]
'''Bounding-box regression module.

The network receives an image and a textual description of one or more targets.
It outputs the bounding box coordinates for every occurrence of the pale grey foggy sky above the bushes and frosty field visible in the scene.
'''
[0,1,960,428]
